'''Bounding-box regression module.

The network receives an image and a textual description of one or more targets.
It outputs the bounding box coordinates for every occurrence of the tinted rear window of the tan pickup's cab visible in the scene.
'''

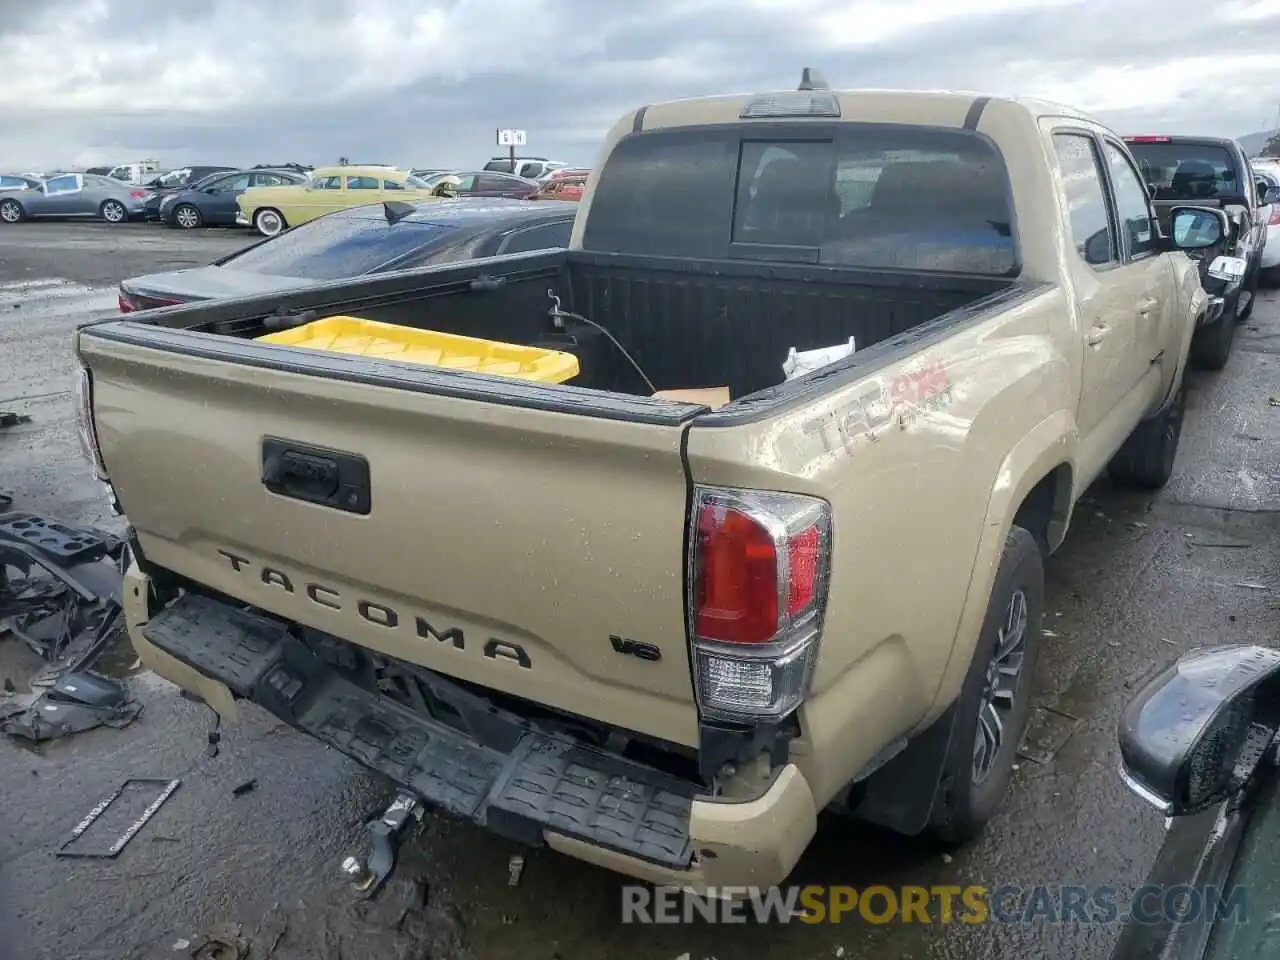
[582,124,1018,276]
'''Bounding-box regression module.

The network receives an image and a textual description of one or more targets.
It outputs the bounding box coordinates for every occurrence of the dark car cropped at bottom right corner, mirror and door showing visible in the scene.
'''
[1111,645,1280,960]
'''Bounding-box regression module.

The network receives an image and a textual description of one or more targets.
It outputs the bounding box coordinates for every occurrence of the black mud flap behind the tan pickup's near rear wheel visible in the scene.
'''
[851,704,956,837]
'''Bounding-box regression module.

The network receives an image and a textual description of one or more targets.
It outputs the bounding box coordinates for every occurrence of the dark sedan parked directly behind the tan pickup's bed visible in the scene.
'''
[120,198,577,312]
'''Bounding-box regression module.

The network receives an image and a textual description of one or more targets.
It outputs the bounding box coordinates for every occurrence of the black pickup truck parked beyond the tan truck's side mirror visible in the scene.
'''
[1125,134,1270,370]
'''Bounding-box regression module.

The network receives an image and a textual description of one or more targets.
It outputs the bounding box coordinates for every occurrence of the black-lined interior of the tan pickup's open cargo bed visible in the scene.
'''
[110,251,1015,399]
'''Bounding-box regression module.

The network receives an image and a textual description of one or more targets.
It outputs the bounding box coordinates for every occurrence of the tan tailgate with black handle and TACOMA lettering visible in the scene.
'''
[79,323,699,745]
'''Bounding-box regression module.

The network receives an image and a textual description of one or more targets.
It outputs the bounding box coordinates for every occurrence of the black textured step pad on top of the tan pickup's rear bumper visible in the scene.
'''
[142,594,696,869]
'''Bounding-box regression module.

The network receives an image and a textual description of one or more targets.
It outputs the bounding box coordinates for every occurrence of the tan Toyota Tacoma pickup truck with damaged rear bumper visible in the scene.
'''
[77,77,1225,890]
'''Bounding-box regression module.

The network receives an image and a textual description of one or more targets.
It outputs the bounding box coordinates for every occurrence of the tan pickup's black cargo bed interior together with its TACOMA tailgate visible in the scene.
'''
[78,251,1024,748]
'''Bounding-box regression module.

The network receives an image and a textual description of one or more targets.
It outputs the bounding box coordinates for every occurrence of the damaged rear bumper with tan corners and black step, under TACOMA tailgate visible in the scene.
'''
[125,566,817,891]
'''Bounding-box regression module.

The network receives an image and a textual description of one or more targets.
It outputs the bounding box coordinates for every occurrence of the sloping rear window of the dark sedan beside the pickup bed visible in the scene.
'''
[219,207,453,280]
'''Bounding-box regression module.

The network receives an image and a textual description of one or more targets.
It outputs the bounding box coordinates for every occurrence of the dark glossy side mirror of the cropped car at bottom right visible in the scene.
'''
[1120,645,1280,817]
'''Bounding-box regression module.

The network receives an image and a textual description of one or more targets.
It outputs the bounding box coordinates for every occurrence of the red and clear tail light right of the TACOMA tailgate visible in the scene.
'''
[689,486,831,718]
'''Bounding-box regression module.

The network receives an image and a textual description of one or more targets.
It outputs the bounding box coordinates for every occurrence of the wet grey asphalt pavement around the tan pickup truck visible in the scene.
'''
[0,224,1280,960]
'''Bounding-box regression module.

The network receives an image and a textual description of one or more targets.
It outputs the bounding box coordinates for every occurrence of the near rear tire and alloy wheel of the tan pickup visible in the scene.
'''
[925,526,1044,845]
